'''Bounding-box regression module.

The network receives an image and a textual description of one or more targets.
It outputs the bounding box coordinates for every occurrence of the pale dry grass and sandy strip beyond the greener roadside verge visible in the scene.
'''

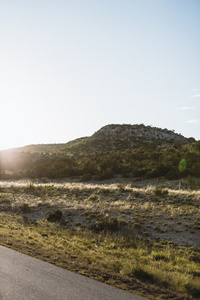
[0,179,200,250]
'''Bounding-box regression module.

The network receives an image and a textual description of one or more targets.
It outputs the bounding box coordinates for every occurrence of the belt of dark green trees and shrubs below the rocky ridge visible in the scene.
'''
[0,141,200,180]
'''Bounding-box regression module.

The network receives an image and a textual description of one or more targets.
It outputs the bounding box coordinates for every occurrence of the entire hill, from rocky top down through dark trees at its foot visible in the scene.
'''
[0,124,200,180]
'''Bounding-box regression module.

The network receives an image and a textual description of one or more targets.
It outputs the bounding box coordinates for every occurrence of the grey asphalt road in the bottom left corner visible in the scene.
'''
[0,246,146,300]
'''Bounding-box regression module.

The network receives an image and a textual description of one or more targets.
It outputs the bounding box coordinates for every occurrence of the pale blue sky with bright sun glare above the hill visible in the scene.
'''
[0,0,200,149]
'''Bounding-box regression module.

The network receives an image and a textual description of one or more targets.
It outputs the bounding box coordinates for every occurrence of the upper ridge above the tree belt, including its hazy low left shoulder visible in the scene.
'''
[9,124,195,155]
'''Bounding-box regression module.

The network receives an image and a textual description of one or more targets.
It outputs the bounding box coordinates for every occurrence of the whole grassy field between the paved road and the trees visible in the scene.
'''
[0,181,200,299]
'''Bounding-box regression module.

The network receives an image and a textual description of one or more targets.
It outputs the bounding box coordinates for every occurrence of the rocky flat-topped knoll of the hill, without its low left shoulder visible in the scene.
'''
[62,124,195,153]
